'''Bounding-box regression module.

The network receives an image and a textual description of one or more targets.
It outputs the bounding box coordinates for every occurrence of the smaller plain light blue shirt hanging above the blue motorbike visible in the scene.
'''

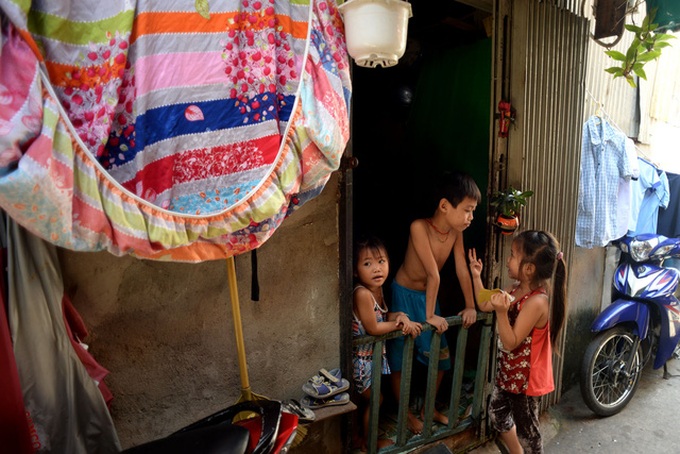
[628,158,670,235]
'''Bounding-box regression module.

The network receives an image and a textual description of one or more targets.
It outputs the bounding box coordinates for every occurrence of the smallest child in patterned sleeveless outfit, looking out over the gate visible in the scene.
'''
[352,237,422,450]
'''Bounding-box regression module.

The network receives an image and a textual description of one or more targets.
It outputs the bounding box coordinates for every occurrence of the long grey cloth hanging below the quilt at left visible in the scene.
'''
[3,220,121,454]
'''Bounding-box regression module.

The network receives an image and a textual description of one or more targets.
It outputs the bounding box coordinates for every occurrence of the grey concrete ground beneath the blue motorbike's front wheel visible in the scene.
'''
[471,359,680,454]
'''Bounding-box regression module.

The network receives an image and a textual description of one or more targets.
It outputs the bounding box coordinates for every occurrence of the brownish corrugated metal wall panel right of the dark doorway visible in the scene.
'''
[490,0,588,406]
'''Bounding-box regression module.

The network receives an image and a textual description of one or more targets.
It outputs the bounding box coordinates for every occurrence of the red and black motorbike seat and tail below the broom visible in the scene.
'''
[124,400,298,454]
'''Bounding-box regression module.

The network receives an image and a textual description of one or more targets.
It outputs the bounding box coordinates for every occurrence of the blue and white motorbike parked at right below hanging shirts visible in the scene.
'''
[580,234,680,416]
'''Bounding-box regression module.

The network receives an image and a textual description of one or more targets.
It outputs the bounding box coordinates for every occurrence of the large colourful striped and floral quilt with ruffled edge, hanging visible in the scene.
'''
[0,0,351,262]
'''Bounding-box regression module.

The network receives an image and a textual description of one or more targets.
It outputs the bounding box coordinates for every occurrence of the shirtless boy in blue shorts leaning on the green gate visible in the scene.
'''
[387,172,481,433]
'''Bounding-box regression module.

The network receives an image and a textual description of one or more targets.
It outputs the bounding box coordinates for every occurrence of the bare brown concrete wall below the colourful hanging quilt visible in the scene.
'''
[59,176,340,452]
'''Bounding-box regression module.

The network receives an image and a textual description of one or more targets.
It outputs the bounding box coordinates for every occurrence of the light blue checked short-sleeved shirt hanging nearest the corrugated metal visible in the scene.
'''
[576,115,633,248]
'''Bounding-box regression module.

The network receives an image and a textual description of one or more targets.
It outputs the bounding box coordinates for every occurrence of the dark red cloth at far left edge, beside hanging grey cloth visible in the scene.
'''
[0,250,35,454]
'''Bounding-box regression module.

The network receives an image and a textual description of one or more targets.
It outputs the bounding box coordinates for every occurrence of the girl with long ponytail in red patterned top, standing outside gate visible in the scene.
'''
[469,230,567,454]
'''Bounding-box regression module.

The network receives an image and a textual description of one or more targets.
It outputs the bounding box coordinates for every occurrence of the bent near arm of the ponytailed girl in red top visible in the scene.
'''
[491,292,548,350]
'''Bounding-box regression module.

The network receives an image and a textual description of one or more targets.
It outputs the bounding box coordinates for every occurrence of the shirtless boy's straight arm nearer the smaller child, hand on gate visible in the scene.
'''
[409,219,449,334]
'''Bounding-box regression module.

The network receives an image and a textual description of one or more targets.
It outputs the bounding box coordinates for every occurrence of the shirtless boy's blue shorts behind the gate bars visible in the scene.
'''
[387,281,451,372]
